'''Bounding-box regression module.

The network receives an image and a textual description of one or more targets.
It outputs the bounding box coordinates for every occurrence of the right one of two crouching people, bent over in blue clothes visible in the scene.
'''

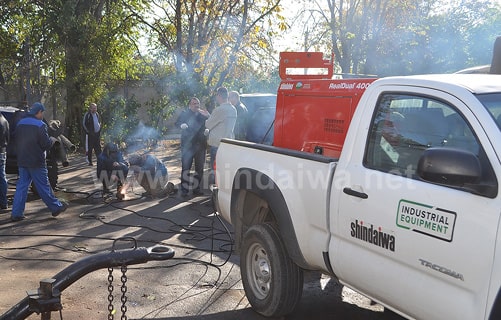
[128,153,174,197]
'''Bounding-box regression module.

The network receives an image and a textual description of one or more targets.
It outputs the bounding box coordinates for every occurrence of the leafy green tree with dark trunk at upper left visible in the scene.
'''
[0,0,148,139]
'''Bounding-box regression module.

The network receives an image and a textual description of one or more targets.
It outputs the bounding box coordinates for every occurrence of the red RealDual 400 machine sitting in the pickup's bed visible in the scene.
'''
[273,52,376,158]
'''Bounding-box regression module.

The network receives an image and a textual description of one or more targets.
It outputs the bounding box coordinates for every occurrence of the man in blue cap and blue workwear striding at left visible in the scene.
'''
[11,102,68,221]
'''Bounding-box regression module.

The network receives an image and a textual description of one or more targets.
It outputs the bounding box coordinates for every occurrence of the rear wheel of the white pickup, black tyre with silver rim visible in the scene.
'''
[240,224,303,317]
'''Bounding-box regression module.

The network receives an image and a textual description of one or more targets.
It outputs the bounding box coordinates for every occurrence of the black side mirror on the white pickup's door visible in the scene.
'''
[417,147,482,189]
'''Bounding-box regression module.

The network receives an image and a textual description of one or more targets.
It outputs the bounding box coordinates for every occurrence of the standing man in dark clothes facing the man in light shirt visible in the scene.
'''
[175,97,209,197]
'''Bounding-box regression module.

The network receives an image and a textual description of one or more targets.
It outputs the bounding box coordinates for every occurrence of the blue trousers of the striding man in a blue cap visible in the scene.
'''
[12,167,63,217]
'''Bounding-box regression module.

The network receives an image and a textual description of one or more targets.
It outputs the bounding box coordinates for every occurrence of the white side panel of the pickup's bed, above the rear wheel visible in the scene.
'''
[216,139,337,272]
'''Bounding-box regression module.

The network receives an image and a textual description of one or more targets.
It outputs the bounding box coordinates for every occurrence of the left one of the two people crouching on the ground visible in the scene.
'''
[97,142,129,200]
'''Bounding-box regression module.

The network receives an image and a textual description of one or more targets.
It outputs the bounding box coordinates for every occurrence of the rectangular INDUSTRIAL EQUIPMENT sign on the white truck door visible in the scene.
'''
[397,199,456,242]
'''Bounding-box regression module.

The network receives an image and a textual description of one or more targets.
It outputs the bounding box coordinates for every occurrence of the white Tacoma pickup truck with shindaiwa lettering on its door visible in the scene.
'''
[214,74,501,320]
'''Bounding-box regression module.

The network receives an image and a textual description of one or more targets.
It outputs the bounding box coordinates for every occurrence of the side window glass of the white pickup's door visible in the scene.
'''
[364,93,481,179]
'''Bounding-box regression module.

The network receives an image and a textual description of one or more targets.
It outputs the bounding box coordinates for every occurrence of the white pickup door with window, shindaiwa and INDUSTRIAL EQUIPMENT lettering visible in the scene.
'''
[330,87,500,319]
